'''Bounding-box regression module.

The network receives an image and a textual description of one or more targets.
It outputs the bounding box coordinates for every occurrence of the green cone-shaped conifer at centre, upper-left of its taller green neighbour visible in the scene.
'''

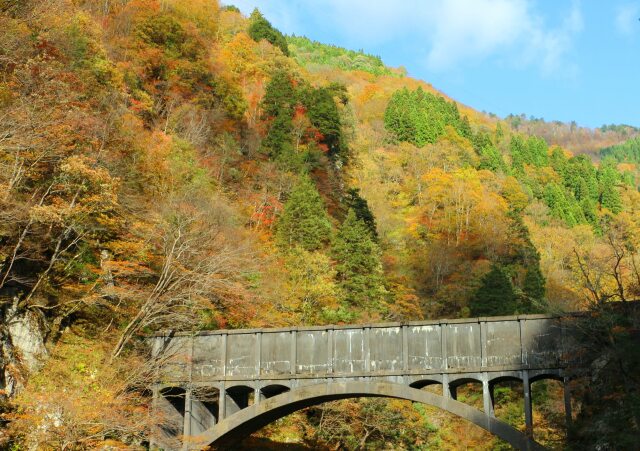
[276,175,331,251]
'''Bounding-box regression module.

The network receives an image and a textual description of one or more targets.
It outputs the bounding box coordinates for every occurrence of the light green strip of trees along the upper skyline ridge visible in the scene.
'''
[287,36,396,75]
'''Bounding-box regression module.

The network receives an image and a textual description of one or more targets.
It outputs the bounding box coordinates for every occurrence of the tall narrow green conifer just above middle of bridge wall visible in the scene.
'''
[331,209,385,310]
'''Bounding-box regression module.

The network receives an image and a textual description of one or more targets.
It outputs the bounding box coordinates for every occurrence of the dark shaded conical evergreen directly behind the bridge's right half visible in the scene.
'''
[469,265,517,316]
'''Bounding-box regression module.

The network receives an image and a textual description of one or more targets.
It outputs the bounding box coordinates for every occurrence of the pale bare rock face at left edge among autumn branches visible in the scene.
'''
[0,302,48,398]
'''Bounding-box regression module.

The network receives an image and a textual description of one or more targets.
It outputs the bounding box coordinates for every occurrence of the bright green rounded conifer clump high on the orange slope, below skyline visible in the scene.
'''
[384,87,470,147]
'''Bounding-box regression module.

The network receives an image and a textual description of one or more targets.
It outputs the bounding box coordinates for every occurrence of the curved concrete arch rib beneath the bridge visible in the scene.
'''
[185,381,544,450]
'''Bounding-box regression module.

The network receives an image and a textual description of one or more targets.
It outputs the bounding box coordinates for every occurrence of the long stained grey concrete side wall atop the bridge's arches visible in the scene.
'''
[154,315,573,383]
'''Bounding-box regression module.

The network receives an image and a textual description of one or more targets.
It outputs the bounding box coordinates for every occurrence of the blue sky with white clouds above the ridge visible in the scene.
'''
[228,0,640,127]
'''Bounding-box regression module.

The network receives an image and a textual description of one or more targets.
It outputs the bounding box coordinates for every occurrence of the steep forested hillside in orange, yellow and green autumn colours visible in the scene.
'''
[0,0,640,450]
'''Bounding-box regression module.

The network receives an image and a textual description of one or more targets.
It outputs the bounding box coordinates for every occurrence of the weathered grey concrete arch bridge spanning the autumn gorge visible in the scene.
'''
[152,315,579,450]
